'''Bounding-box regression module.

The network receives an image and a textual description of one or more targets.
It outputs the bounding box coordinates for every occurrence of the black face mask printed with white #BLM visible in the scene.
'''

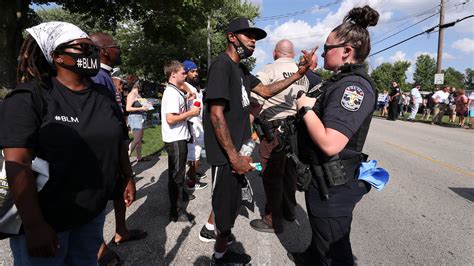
[60,45,100,77]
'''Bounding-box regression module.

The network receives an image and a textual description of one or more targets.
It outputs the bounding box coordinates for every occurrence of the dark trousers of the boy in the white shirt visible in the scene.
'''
[165,140,189,217]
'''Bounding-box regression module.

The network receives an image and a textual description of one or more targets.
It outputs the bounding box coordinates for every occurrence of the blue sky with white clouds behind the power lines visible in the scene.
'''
[247,0,474,81]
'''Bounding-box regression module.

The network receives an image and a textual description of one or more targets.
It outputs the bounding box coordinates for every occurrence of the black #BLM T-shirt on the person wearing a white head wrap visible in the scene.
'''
[0,78,127,231]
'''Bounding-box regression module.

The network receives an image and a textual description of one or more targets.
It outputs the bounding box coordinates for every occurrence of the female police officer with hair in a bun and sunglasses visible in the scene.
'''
[293,6,379,265]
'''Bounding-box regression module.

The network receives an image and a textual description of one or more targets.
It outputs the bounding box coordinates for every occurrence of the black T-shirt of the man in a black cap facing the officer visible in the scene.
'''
[203,53,260,165]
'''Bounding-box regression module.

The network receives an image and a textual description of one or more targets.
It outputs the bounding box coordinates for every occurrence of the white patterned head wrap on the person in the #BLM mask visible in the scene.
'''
[26,21,89,64]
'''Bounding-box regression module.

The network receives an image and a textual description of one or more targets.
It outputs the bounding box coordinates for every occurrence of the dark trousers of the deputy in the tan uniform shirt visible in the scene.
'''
[260,137,296,230]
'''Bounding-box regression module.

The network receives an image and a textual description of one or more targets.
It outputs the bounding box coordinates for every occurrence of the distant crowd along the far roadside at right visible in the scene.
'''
[377,81,474,128]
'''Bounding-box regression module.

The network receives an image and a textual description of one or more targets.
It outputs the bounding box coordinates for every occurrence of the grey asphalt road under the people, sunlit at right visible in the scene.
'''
[0,118,474,265]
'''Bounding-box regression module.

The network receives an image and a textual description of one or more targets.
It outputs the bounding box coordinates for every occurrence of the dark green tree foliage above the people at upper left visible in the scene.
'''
[0,0,259,88]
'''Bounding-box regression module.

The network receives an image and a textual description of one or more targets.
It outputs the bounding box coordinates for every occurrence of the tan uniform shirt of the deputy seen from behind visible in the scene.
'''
[251,58,309,121]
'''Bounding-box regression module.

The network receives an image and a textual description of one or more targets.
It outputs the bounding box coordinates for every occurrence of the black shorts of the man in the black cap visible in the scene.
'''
[212,164,244,235]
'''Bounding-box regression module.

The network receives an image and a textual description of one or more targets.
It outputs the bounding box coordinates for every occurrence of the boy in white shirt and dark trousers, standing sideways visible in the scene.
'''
[161,60,201,222]
